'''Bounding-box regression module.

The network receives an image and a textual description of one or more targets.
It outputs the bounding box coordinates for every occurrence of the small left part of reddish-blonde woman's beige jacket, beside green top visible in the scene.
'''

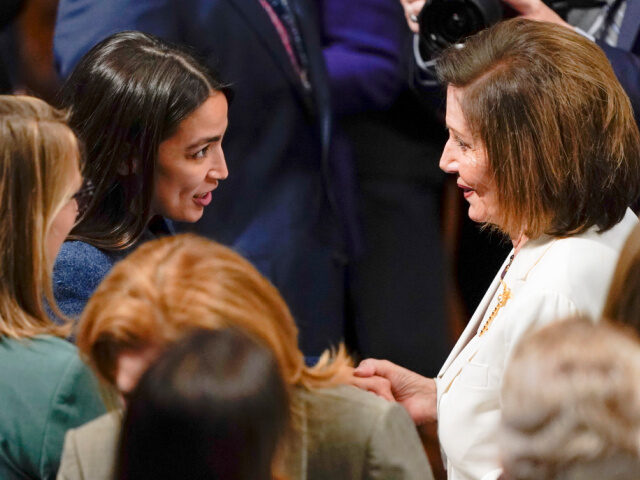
[58,412,122,480]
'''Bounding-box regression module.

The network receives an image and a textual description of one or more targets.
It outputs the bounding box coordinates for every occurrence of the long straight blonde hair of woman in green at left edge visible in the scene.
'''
[0,95,80,338]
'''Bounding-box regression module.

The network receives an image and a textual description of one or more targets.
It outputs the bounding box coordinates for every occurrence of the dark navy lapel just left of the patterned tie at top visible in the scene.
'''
[229,0,306,103]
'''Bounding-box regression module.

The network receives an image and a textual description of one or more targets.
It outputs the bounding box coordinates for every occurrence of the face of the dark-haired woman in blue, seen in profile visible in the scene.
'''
[151,92,228,222]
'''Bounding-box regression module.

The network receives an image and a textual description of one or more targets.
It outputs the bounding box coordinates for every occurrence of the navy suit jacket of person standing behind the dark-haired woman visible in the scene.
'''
[54,0,354,355]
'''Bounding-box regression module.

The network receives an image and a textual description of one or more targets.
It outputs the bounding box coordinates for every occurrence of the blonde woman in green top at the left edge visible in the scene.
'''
[0,95,104,480]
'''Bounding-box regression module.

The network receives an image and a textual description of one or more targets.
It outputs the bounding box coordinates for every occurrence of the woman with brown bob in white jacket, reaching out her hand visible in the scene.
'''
[354,19,640,480]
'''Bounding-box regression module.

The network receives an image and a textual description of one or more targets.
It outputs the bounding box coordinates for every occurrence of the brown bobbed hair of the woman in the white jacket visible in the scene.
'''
[437,18,640,238]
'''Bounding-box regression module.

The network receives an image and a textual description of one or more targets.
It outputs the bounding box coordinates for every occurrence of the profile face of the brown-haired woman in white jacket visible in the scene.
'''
[440,86,499,223]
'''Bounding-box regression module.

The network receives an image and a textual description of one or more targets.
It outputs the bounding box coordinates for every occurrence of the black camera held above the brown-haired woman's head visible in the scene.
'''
[418,0,607,58]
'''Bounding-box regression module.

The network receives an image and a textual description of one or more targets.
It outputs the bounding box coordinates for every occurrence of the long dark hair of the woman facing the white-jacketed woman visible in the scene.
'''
[60,32,229,250]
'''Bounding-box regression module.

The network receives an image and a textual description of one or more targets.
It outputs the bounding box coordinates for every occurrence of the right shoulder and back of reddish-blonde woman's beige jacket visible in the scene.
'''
[296,385,431,479]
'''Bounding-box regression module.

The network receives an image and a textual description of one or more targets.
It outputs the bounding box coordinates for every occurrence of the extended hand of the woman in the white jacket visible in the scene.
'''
[351,358,437,425]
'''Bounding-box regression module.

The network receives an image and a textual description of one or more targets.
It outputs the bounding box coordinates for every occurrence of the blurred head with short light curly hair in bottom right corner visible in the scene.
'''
[501,318,640,480]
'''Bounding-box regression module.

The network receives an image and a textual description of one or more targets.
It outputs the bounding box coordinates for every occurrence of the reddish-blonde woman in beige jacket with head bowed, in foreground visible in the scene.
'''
[59,235,432,480]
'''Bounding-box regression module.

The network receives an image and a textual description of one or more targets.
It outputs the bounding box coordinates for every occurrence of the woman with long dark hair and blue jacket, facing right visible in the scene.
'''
[54,32,229,316]
